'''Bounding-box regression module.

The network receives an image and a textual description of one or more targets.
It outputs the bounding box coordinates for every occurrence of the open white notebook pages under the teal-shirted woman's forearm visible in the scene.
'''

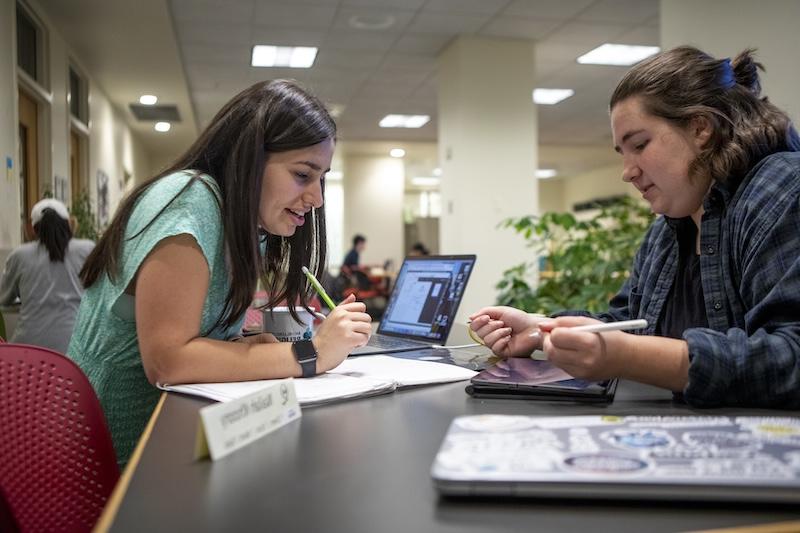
[159,355,476,407]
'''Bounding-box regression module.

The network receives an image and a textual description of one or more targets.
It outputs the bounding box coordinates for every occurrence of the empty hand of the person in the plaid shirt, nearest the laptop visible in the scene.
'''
[469,306,549,357]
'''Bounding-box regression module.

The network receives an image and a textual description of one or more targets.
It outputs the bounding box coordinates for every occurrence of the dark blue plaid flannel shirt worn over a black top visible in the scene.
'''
[572,152,800,408]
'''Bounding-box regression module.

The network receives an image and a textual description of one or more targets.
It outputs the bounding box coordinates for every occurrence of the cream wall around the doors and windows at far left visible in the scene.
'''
[0,0,152,249]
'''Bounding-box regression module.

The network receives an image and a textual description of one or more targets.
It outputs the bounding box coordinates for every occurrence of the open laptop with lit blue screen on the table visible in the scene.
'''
[350,255,475,355]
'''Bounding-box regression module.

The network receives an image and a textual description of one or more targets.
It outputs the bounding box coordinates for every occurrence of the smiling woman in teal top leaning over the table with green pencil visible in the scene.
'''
[68,80,371,464]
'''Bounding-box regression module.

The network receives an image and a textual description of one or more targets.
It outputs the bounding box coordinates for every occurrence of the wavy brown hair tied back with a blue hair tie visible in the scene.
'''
[609,46,800,182]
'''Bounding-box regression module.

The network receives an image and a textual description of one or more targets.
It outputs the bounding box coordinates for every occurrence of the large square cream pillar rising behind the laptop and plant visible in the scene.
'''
[438,37,538,321]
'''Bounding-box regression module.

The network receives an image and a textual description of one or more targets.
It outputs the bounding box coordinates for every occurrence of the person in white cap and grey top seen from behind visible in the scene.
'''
[0,198,94,354]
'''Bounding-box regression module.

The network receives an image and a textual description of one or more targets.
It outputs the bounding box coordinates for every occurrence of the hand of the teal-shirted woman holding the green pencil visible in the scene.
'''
[313,294,372,373]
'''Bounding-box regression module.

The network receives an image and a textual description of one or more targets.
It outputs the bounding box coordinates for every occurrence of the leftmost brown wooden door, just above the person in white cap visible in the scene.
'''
[19,91,39,240]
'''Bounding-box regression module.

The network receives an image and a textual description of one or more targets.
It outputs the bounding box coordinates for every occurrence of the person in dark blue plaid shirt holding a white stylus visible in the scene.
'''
[471,46,800,408]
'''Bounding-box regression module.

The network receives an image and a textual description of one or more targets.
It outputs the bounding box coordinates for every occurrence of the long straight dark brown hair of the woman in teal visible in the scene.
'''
[81,80,336,327]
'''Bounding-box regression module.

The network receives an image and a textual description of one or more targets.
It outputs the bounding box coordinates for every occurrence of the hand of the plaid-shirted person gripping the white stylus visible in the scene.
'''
[539,316,630,380]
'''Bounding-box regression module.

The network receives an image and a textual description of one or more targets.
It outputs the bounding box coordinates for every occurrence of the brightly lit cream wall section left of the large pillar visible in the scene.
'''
[344,155,405,265]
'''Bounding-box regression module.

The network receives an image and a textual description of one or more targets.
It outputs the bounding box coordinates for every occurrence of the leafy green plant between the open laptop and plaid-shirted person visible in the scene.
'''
[496,196,654,314]
